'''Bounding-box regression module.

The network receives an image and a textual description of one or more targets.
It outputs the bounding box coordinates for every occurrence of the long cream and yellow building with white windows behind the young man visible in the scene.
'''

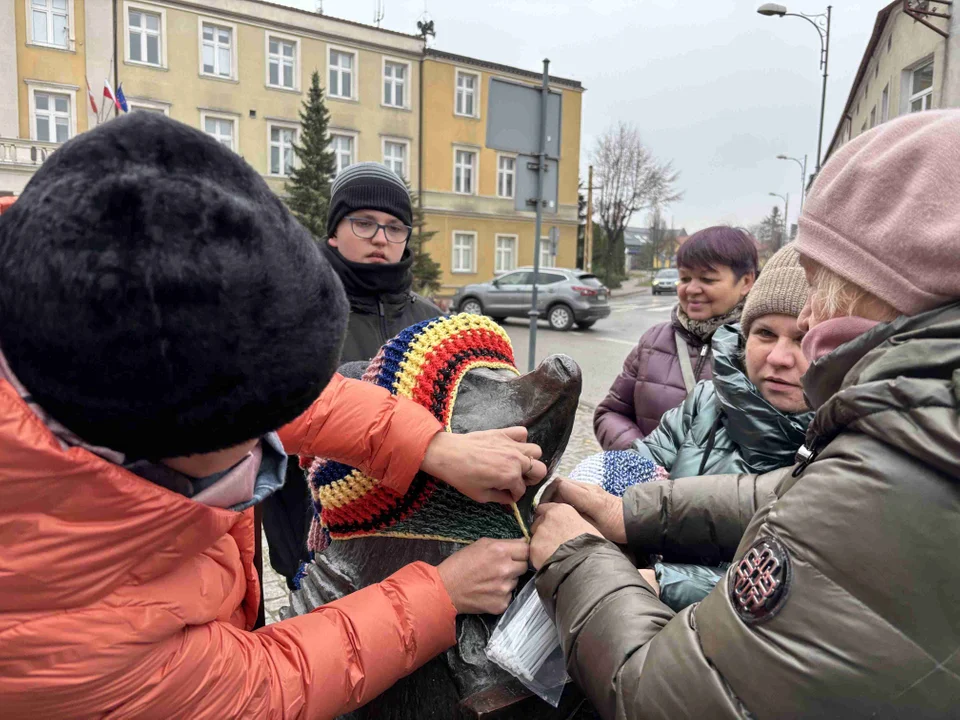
[0,0,583,294]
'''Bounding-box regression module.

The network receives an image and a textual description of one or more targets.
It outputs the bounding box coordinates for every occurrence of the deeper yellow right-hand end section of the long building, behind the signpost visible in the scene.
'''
[421,50,583,294]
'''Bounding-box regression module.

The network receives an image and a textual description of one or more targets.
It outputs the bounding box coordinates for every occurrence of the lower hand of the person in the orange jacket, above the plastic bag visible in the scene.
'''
[437,538,530,615]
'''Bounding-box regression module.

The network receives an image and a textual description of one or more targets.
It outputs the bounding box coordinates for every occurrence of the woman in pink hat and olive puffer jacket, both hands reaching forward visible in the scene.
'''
[531,110,960,718]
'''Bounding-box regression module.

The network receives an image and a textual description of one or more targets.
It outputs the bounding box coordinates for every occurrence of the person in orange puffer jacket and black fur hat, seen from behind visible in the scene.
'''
[0,113,544,719]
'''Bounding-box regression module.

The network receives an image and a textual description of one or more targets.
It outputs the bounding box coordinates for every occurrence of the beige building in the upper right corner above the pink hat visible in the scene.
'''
[826,0,960,157]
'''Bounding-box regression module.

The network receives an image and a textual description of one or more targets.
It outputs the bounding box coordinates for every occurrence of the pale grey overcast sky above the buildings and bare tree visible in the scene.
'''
[275,0,888,232]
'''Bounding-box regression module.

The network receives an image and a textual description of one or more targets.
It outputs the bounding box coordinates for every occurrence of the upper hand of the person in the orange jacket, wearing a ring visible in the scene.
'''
[420,427,547,505]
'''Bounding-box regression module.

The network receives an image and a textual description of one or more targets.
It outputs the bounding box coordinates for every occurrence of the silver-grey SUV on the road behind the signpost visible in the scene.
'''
[453,267,610,330]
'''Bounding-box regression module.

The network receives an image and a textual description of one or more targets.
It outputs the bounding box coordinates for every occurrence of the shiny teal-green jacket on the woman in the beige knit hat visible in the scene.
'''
[641,325,813,479]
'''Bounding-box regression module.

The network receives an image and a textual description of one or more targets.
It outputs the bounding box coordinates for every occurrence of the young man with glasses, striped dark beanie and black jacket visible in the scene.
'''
[263,162,443,587]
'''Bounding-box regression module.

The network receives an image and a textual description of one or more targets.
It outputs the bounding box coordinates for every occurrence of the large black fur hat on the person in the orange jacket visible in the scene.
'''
[0,113,347,459]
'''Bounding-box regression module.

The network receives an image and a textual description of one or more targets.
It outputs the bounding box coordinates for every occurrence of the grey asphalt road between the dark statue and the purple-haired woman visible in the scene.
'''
[503,291,677,406]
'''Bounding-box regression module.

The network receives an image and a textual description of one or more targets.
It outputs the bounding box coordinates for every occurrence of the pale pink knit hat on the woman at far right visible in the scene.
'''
[796,110,960,315]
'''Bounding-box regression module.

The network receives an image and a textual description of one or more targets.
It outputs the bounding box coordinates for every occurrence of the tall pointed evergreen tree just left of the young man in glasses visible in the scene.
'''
[287,70,337,238]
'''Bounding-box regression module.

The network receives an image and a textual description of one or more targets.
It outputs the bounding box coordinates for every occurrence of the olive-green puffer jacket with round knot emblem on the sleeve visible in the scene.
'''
[537,303,960,720]
